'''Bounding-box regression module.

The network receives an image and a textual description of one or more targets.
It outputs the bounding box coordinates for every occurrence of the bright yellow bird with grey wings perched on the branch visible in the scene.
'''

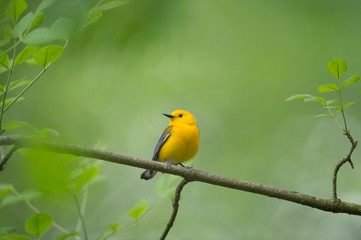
[140,110,199,180]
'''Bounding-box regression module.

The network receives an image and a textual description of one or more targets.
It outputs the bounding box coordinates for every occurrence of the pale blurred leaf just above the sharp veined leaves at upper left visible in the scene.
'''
[23,27,63,45]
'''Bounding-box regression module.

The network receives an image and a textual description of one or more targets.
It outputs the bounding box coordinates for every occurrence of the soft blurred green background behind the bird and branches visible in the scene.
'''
[0,0,361,239]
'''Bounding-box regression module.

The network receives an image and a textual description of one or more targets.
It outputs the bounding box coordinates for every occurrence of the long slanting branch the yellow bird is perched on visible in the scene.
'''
[0,135,361,216]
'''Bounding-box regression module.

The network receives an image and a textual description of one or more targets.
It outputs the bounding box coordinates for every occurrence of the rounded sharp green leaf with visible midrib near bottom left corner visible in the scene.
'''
[25,213,53,237]
